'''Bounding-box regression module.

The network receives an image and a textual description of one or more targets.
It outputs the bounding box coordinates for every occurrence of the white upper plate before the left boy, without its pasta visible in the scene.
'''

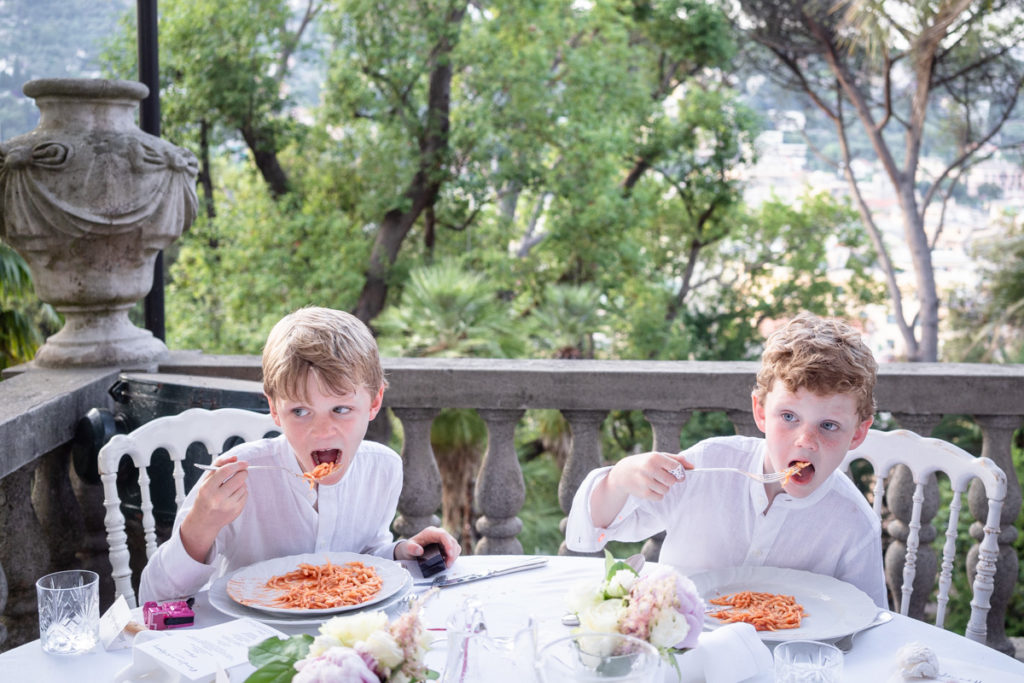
[226,553,409,616]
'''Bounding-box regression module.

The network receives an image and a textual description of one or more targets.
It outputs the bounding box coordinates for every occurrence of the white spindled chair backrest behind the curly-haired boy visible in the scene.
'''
[843,429,1007,643]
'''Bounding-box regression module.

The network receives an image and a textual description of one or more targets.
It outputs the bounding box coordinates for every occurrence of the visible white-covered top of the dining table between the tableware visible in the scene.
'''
[0,555,1024,683]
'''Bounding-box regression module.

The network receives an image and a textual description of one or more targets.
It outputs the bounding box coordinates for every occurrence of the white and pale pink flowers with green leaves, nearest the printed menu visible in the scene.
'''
[246,592,437,683]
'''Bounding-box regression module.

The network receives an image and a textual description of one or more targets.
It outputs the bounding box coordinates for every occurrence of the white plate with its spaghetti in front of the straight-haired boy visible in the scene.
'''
[226,553,409,615]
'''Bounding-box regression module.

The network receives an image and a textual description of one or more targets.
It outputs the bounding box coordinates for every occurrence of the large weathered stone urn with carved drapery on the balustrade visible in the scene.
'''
[0,79,199,369]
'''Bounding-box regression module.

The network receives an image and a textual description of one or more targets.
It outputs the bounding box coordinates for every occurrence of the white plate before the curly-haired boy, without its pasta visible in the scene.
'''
[690,566,879,642]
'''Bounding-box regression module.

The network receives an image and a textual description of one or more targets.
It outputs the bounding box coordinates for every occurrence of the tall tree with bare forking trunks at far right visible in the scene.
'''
[739,0,1024,360]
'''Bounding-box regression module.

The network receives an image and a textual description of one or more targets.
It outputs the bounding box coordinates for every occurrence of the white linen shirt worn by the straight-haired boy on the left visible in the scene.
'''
[138,435,402,604]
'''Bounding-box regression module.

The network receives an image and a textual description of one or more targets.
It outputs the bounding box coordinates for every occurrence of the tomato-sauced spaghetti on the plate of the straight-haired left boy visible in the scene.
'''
[266,560,383,609]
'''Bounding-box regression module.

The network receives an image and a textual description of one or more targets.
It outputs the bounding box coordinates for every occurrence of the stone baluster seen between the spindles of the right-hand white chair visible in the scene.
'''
[876,413,942,620]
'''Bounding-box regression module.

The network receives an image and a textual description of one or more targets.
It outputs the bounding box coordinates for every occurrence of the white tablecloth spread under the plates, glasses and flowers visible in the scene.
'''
[0,556,1024,683]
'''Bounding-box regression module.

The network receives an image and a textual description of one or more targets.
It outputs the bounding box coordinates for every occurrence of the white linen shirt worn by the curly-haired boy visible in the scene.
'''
[565,436,888,607]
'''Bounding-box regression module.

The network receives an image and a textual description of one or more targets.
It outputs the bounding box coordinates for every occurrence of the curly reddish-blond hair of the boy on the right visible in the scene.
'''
[754,312,879,420]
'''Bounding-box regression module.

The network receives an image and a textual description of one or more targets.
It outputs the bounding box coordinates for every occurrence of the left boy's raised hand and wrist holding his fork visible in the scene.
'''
[179,456,249,563]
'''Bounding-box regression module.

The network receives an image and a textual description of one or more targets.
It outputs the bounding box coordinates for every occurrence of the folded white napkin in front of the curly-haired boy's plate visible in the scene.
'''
[684,623,772,683]
